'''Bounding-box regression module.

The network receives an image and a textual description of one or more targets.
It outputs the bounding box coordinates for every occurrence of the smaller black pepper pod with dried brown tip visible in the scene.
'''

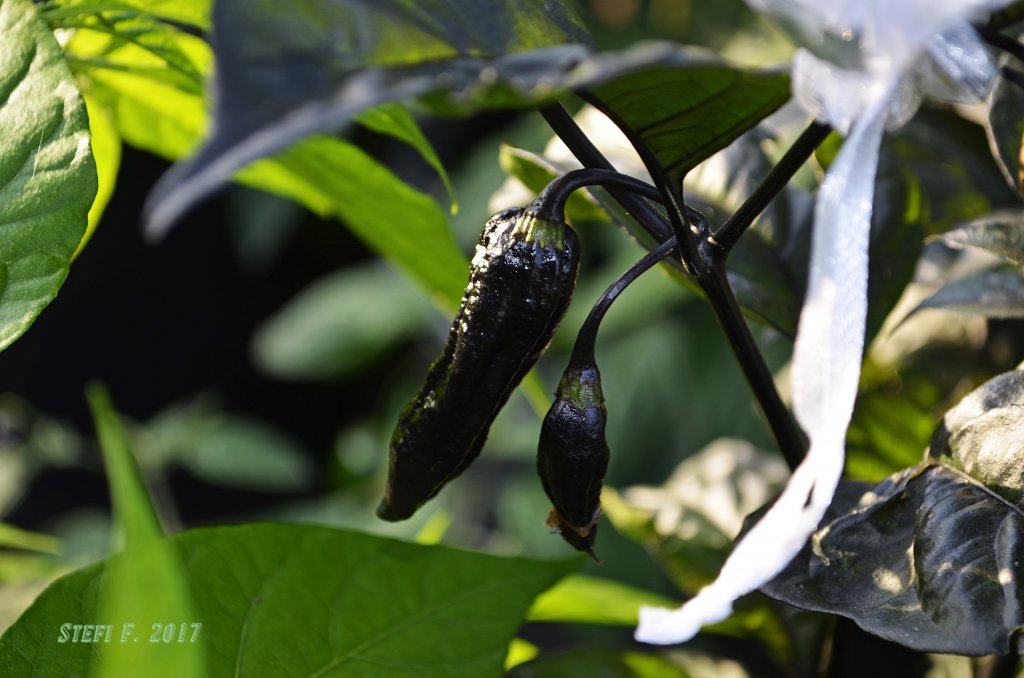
[537,355,609,560]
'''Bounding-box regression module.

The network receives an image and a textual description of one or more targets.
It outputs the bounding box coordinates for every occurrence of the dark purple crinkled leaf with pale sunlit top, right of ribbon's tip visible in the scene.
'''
[762,371,1024,654]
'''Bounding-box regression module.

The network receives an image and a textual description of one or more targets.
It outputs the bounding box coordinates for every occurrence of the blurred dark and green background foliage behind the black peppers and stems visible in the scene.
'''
[0,0,1024,676]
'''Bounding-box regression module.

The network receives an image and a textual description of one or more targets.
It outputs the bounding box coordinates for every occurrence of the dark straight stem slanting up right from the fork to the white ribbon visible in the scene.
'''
[710,122,831,258]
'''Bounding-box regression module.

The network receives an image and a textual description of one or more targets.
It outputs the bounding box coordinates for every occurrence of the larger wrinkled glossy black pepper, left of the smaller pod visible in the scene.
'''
[377,208,580,521]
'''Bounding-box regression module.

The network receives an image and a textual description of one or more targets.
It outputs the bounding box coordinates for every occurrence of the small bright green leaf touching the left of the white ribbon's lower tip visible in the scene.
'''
[526,575,675,626]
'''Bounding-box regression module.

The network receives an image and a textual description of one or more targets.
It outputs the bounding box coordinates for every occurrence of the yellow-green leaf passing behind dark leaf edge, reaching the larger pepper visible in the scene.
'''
[80,29,469,310]
